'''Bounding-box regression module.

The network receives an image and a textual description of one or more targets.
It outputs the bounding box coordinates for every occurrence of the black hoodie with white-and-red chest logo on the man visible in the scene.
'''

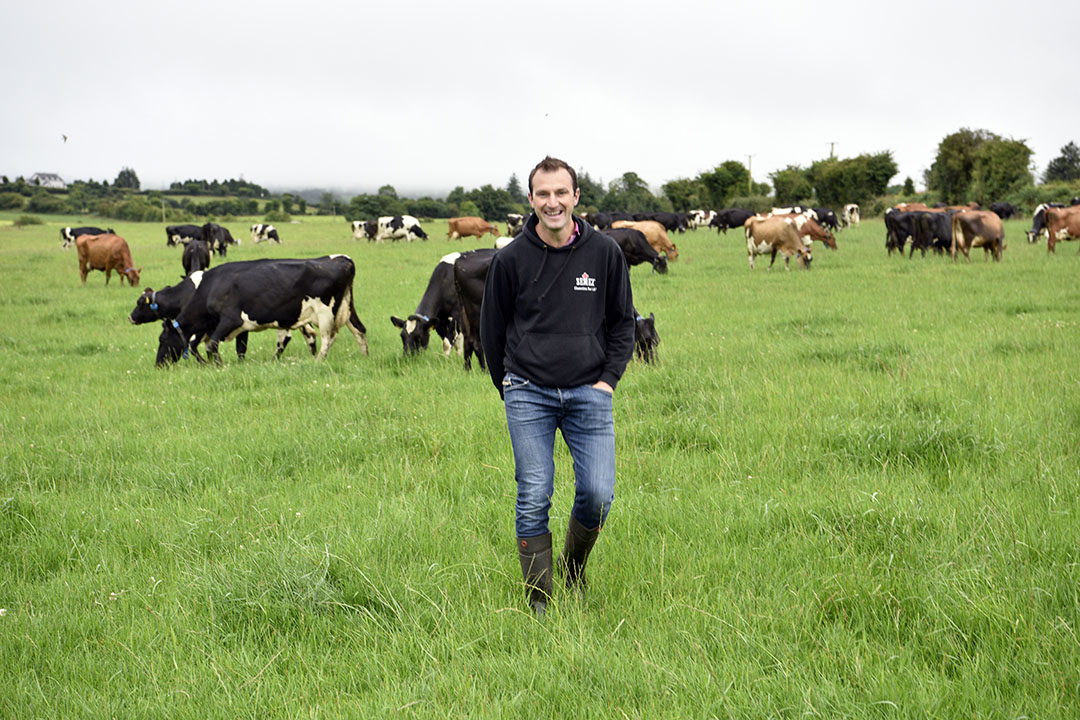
[480,214,634,394]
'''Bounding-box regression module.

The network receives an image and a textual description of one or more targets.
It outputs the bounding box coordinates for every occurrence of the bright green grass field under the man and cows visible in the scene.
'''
[0,214,1080,720]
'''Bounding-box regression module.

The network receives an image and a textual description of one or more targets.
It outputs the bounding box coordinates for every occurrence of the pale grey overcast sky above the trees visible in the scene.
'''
[0,0,1080,196]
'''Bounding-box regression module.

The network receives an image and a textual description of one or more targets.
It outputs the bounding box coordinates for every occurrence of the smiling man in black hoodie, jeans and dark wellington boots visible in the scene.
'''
[480,157,634,615]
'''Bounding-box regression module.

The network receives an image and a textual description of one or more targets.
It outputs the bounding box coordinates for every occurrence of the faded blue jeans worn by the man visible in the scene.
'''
[502,372,615,538]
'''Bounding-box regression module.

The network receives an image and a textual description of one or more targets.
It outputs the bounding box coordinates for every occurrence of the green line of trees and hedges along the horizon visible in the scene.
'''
[0,127,1080,222]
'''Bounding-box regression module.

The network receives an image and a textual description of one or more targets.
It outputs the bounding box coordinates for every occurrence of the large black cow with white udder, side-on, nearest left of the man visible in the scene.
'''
[159,255,367,363]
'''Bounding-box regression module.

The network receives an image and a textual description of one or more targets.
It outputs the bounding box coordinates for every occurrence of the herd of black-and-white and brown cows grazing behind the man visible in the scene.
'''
[60,198,1080,369]
